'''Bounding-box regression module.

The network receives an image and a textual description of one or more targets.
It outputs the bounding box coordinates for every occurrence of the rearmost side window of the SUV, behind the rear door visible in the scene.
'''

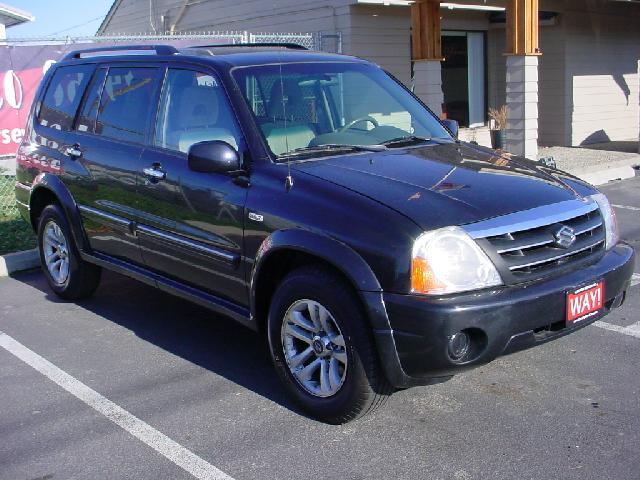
[38,65,94,130]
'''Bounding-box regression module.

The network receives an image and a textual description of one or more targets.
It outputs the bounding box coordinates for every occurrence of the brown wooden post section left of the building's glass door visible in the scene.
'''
[411,0,442,60]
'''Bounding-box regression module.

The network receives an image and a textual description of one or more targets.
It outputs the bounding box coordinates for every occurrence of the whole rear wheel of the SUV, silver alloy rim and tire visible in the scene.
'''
[38,204,101,300]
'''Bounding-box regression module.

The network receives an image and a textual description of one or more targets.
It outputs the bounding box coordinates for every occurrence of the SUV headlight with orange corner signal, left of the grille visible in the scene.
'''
[411,227,502,295]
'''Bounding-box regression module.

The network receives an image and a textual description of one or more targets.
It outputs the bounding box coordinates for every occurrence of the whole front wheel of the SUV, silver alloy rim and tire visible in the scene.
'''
[268,266,390,424]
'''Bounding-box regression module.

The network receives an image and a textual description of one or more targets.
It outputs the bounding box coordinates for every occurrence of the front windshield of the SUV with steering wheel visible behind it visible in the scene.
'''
[234,62,451,157]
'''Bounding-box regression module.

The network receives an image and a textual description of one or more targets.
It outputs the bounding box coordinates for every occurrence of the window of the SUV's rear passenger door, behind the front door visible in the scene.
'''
[95,67,158,143]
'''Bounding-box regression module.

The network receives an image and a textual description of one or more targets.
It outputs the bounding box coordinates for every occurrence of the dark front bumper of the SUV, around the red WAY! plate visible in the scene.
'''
[371,244,635,388]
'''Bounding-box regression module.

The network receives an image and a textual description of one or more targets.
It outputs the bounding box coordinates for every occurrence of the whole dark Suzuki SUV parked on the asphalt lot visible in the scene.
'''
[16,45,634,423]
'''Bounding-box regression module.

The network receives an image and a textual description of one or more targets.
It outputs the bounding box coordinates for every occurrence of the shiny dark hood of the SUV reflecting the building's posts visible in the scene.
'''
[292,143,579,230]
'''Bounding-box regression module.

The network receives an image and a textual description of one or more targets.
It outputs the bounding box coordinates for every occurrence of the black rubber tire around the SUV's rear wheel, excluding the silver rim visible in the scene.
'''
[38,204,102,300]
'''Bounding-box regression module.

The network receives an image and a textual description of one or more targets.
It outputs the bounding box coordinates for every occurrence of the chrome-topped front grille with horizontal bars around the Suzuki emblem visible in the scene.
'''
[467,200,606,283]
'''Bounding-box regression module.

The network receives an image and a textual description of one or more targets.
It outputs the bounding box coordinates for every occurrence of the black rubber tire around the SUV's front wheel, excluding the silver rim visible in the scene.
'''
[268,265,392,424]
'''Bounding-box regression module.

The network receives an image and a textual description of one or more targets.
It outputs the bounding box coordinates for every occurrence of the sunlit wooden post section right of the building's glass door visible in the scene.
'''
[506,0,540,55]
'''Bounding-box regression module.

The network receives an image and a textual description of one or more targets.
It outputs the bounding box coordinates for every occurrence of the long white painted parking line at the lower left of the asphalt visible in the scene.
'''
[0,332,233,480]
